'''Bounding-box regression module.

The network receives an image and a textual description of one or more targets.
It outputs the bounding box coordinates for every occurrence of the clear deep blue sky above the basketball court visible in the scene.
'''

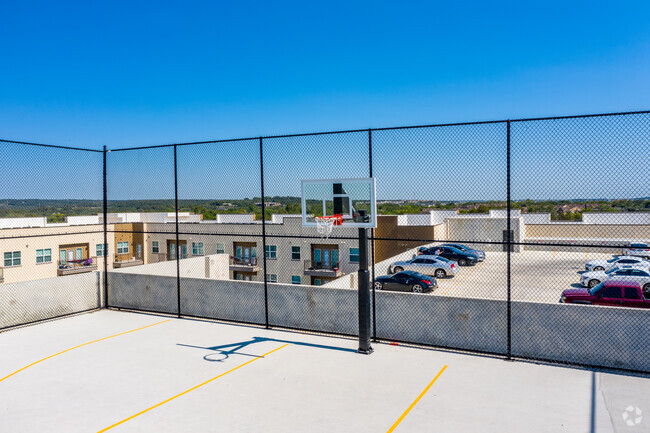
[0,1,650,199]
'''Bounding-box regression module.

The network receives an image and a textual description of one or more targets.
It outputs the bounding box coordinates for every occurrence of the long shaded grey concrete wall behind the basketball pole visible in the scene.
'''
[109,272,650,371]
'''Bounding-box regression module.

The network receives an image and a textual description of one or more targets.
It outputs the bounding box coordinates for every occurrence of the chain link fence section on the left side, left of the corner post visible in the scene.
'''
[0,140,104,329]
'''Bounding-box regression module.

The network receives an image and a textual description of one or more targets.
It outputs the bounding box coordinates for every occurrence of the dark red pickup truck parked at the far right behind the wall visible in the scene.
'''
[560,280,650,308]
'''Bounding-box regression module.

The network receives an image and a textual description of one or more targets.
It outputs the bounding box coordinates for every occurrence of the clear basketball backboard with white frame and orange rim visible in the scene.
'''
[301,177,377,228]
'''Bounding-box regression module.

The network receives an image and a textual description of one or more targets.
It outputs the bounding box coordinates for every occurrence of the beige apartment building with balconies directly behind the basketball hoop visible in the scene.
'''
[145,215,359,285]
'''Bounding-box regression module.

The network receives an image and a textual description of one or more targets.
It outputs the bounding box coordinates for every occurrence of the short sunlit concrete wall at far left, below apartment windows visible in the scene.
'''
[0,272,102,328]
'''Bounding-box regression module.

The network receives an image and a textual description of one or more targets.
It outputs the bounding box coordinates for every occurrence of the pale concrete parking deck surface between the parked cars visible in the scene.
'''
[434,251,612,303]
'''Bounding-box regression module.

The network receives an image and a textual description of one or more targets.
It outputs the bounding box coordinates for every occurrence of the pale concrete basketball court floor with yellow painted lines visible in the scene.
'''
[0,310,650,433]
